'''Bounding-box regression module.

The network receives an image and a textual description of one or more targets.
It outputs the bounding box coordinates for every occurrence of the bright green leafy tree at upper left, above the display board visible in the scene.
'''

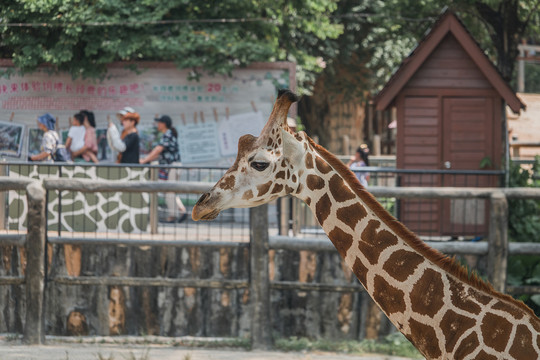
[0,0,341,84]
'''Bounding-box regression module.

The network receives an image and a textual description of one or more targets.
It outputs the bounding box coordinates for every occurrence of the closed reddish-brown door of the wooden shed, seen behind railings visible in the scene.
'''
[441,97,496,235]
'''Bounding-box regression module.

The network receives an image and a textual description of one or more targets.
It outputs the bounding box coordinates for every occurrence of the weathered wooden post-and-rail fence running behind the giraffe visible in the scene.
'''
[0,177,540,348]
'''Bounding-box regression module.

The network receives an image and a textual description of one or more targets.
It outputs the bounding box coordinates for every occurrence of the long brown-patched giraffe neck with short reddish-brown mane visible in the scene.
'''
[296,138,540,359]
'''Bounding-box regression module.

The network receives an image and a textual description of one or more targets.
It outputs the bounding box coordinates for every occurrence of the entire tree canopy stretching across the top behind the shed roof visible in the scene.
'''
[0,0,540,91]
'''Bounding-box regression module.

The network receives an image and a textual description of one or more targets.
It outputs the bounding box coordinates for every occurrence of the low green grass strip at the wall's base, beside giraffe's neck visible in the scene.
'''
[275,333,423,359]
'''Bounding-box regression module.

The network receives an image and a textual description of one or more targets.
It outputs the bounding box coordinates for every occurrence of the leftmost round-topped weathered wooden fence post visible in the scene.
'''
[24,181,46,344]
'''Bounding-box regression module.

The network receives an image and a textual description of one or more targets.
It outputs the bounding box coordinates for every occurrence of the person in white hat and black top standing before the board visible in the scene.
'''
[107,107,140,164]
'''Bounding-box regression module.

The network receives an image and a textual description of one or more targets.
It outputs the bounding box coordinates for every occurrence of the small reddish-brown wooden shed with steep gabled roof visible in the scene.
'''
[374,10,523,236]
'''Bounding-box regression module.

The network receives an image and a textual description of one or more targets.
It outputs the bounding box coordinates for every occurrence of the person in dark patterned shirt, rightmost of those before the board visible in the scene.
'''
[140,115,187,223]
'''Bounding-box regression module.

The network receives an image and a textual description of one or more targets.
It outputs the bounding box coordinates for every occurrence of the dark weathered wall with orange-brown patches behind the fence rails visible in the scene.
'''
[0,245,387,339]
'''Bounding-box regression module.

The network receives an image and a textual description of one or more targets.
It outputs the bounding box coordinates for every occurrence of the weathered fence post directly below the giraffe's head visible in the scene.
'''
[249,205,272,349]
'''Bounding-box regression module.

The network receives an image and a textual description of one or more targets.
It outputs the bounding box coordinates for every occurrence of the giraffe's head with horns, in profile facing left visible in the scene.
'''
[191,90,307,220]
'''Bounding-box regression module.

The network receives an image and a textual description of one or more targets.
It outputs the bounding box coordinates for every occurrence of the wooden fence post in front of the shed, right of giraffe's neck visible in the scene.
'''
[487,191,508,292]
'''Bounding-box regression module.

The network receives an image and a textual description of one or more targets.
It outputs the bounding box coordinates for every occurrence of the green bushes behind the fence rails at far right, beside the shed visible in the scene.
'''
[508,156,540,315]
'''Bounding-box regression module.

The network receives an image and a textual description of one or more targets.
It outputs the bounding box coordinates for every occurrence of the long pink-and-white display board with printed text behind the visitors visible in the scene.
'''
[0,61,295,165]
